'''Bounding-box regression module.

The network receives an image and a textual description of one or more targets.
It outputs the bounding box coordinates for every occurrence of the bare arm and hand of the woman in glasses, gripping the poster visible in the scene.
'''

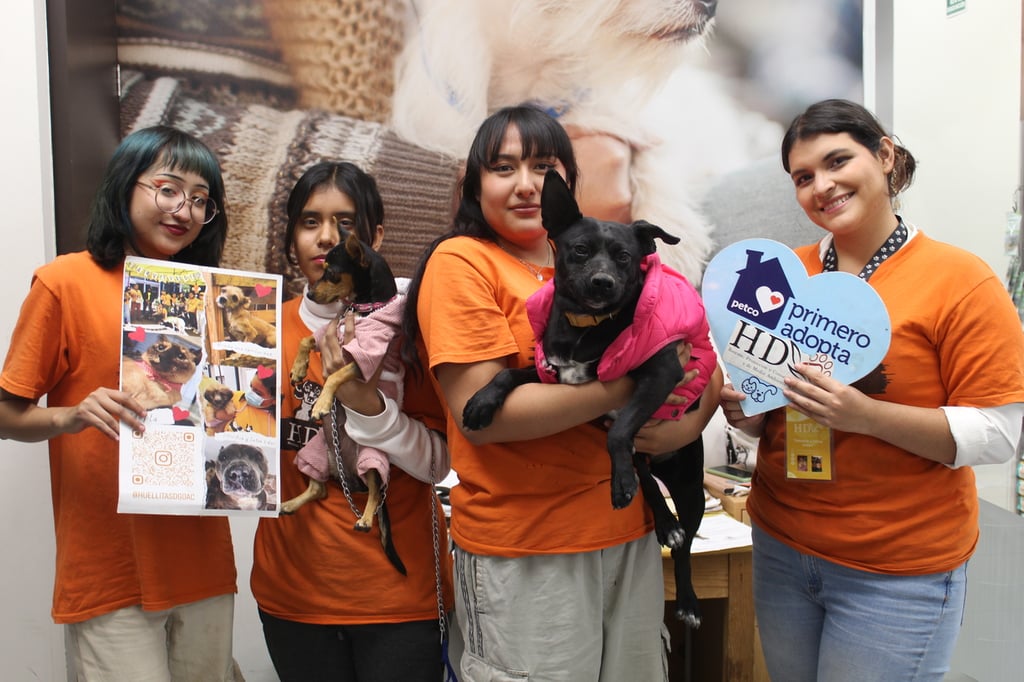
[0,387,145,442]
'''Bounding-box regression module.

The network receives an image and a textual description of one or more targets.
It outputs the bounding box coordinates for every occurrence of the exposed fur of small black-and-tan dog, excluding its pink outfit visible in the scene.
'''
[282,232,407,576]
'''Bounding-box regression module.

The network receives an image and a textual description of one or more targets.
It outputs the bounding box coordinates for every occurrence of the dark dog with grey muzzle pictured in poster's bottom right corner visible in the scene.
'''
[206,443,269,510]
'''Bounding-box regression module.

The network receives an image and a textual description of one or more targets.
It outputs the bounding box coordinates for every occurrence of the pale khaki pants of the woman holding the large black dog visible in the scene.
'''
[453,534,669,682]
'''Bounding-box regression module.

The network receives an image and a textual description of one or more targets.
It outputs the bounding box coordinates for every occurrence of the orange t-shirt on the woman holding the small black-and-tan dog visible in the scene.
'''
[251,298,453,625]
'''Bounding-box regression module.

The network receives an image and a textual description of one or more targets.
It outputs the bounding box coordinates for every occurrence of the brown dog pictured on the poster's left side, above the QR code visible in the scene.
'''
[121,334,202,410]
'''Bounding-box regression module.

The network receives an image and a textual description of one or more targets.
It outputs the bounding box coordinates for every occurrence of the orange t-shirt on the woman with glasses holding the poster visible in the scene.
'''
[0,252,237,623]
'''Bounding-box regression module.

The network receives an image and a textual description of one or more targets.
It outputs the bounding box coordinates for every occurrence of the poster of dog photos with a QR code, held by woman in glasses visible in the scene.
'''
[118,256,283,516]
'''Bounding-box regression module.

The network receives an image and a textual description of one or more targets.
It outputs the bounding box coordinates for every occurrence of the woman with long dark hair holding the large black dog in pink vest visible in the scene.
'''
[407,106,721,681]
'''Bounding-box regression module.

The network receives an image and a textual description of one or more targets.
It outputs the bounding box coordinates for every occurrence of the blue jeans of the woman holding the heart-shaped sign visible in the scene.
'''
[753,518,967,682]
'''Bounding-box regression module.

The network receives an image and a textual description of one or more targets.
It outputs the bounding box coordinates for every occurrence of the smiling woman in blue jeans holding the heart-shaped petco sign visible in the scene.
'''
[722,99,1024,682]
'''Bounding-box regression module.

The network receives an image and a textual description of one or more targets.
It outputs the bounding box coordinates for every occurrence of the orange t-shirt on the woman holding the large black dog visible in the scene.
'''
[418,237,653,557]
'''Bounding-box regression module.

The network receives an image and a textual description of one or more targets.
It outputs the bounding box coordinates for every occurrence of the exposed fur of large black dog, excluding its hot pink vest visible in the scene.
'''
[463,171,705,627]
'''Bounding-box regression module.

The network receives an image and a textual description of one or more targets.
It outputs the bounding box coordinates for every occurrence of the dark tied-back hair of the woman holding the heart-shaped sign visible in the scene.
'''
[782,99,918,202]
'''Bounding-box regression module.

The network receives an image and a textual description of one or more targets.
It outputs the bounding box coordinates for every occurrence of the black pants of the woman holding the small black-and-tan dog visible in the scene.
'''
[259,611,442,682]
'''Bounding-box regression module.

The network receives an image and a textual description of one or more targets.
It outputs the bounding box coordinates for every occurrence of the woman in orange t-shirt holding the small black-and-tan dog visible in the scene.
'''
[252,162,452,682]
